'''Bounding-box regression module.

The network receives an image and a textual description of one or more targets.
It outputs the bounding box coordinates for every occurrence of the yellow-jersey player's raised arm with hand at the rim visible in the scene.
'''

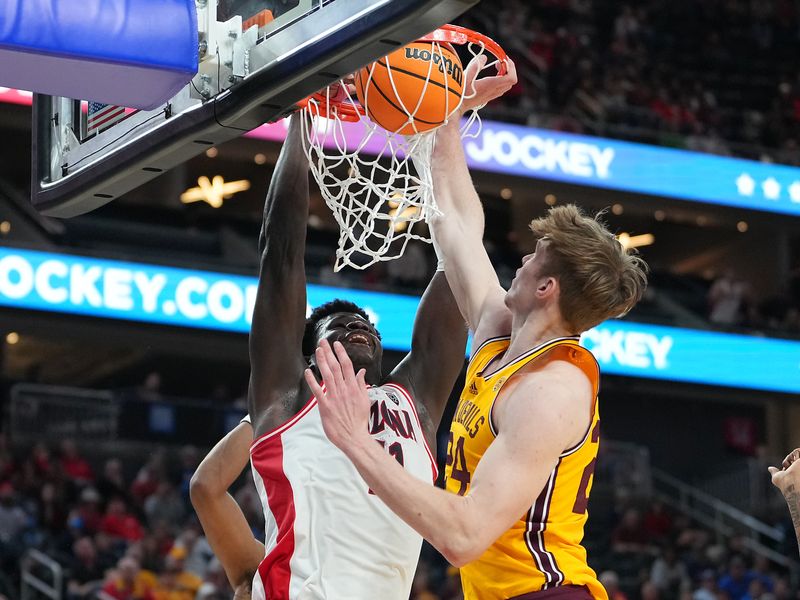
[431,57,516,341]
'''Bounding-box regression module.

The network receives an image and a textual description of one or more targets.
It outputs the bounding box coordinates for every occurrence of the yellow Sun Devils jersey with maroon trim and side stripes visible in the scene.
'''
[445,337,608,600]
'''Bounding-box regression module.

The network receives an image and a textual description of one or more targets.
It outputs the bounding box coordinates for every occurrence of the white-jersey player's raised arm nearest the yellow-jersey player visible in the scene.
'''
[391,271,467,429]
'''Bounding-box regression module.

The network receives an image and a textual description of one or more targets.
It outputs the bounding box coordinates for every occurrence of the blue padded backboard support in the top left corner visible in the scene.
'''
[0,0,198,110]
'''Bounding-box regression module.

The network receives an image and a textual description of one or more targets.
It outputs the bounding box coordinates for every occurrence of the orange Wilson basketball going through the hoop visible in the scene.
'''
[355,42,464,135]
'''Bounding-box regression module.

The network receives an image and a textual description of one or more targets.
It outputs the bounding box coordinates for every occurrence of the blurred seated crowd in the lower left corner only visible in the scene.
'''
[0,437,263,600]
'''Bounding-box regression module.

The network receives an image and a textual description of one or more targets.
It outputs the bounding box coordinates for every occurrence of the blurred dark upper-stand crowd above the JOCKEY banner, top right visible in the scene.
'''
[461,0,800,164]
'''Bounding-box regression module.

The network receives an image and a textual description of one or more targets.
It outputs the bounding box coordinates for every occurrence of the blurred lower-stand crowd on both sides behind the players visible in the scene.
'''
[0,437,798,600]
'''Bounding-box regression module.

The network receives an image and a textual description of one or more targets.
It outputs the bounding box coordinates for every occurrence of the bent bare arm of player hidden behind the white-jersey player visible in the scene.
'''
[189,422,265,589]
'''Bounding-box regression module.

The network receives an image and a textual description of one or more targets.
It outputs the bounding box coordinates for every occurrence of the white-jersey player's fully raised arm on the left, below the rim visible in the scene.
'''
[248,114,308,426]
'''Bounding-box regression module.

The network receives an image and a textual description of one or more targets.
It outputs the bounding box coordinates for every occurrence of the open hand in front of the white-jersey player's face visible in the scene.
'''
[305,340,371,455]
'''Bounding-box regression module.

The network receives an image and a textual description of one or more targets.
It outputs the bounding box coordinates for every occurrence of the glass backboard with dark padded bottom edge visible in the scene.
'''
[31,0,478,217]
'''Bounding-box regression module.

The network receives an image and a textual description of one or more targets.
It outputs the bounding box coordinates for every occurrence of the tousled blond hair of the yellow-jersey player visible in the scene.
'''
[530,204,647,334]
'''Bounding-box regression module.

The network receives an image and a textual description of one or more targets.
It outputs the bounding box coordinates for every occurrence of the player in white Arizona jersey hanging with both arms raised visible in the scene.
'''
[192,115,466,600]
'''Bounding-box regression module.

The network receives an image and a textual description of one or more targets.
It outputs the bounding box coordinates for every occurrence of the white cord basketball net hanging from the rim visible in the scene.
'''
[302,30,499,271]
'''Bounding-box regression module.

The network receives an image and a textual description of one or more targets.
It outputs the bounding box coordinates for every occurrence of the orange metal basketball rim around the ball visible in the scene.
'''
[297,24,508,122]
